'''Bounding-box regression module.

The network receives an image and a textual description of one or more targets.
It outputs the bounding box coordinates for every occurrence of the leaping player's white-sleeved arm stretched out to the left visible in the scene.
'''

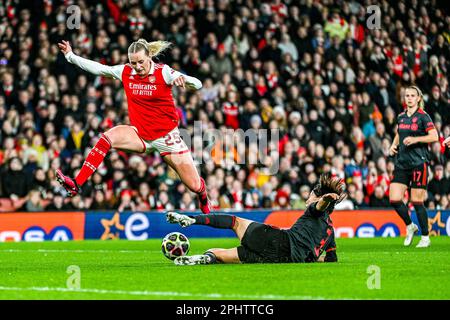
[58,40,125,80]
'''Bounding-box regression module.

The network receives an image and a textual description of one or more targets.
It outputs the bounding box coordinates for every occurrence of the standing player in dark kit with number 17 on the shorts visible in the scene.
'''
[389,86,439,248]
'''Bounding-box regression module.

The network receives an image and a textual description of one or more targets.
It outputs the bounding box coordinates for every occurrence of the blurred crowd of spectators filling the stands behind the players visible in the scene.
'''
[0,0,450,211]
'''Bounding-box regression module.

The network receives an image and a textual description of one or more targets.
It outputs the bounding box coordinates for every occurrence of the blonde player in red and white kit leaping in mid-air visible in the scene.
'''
[56,39,210,213]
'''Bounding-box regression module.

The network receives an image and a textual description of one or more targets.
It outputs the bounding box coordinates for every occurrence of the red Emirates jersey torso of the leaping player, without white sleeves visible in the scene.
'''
[122,63,179,140]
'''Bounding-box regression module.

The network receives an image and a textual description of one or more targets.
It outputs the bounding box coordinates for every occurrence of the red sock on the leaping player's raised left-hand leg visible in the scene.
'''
[75,134,111,187]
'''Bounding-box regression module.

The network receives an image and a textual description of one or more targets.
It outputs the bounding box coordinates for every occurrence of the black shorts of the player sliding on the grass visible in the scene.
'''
[237,222,291,263]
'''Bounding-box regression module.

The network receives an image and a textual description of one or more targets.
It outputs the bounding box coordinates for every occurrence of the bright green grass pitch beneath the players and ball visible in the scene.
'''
[0,236,450,300]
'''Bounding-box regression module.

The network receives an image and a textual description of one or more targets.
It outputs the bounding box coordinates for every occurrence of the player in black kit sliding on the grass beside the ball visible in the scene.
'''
[166,174,345,265]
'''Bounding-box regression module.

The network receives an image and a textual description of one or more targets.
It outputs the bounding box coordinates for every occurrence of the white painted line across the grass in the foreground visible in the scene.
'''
[0,286,342,300]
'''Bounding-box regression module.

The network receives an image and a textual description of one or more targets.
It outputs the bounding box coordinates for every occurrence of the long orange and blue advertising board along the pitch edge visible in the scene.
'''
[0,209,450,242]
